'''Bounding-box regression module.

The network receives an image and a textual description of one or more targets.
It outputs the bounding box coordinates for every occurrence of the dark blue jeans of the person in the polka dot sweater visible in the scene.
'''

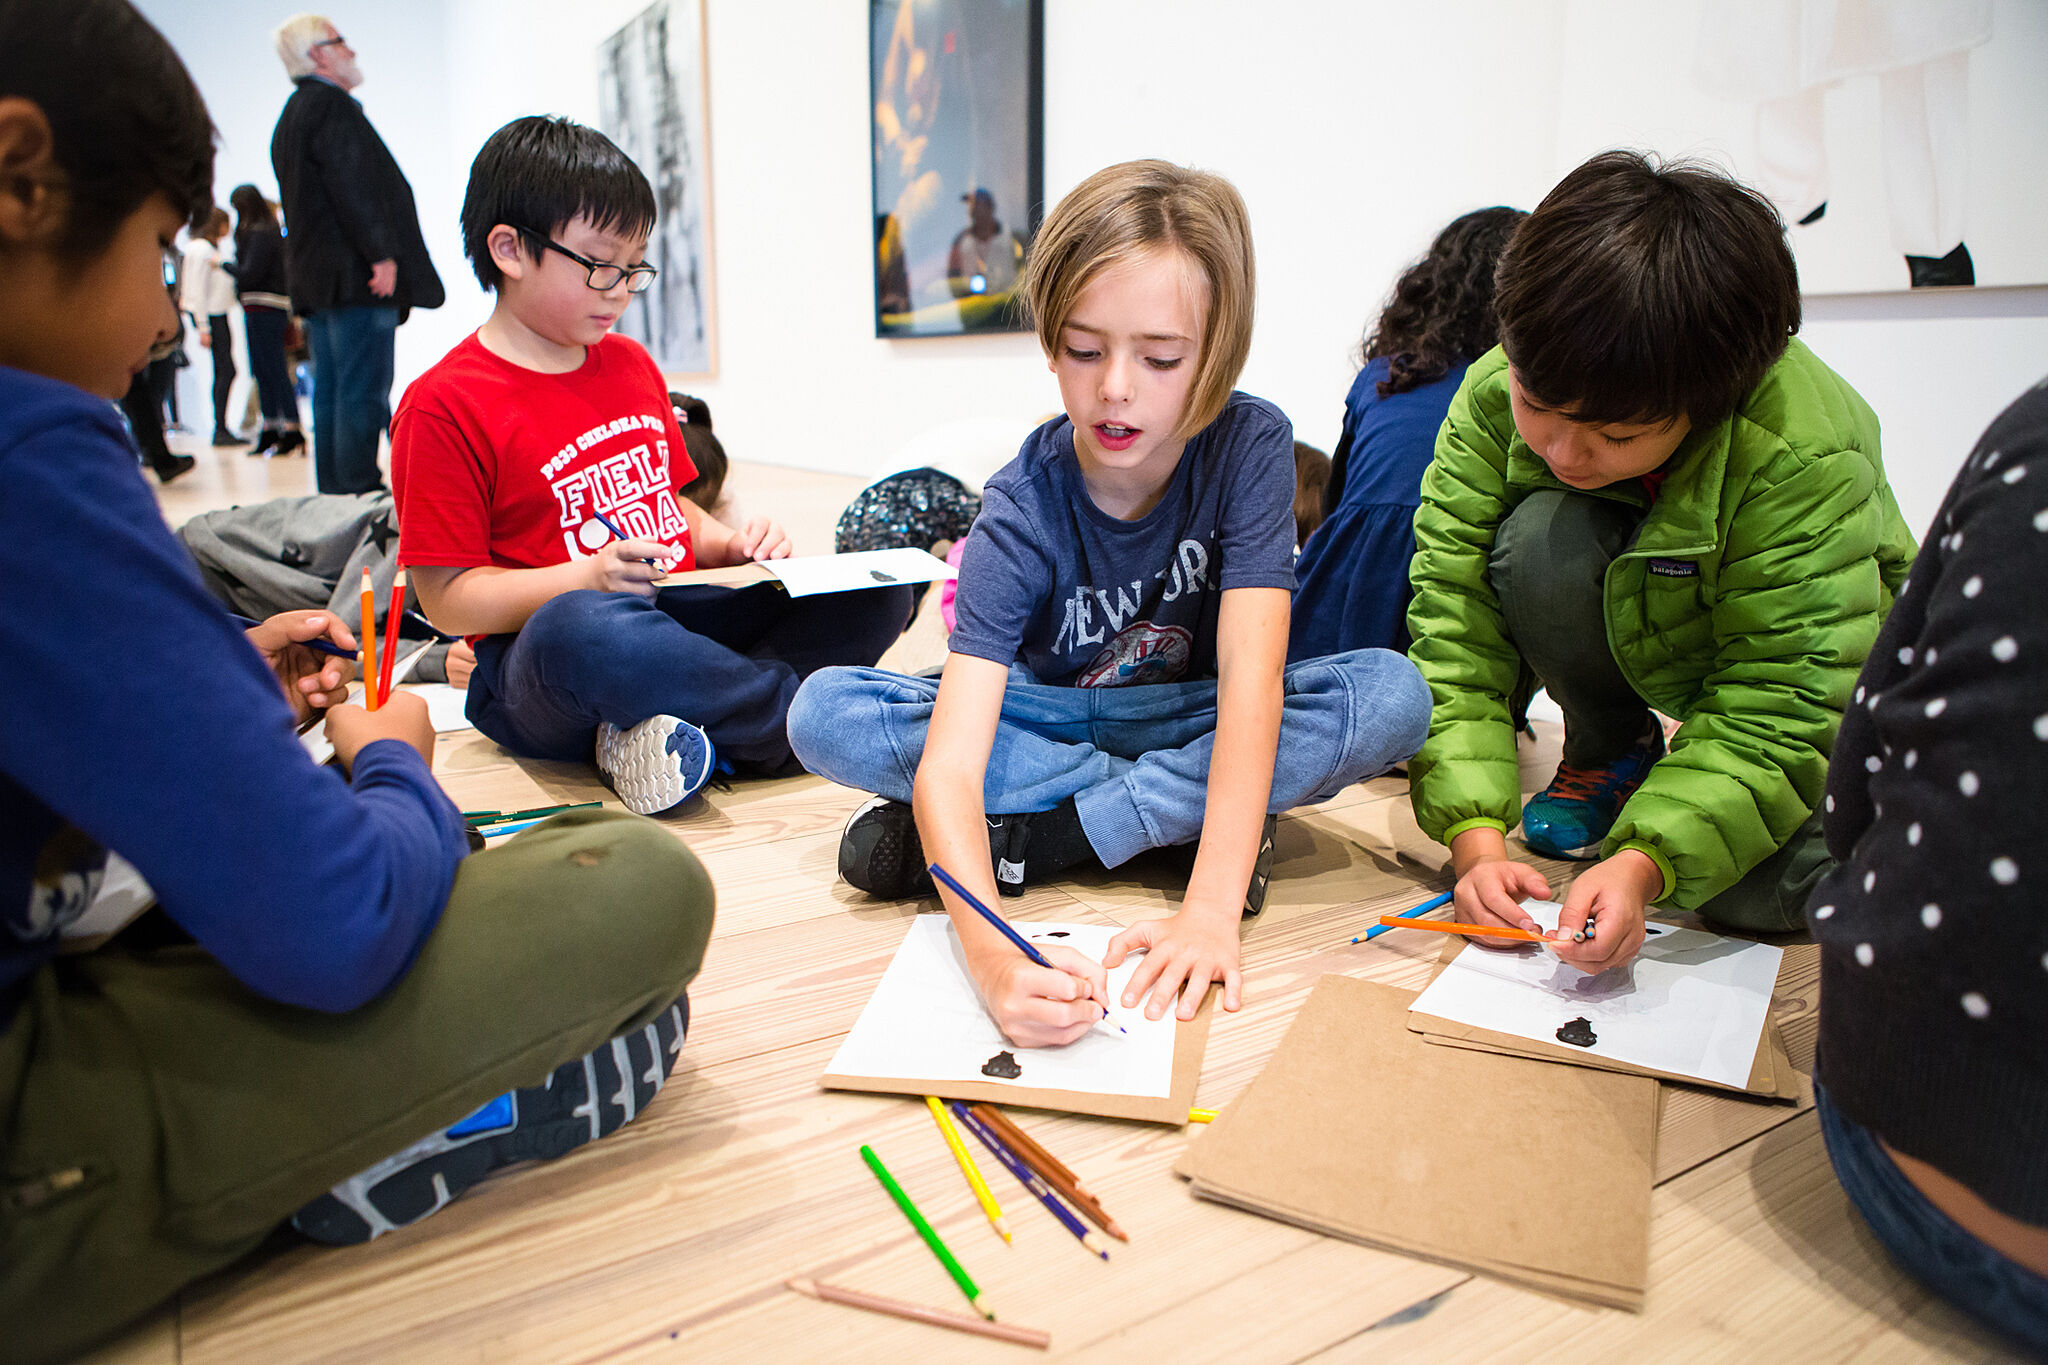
[1812,1085,2048,1361]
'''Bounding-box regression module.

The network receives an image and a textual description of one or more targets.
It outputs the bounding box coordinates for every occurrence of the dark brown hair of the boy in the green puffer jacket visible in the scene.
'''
[1493,151,1800,426]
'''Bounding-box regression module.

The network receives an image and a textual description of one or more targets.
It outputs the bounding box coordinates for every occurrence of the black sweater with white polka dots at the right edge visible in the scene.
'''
[1806,381,2048,1226]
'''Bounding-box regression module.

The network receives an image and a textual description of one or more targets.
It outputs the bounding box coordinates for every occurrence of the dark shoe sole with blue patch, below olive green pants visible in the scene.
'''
[291,995,690,1246]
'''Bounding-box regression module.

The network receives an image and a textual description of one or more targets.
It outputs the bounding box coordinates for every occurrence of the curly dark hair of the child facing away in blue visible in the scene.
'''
[1360,205,1528,399]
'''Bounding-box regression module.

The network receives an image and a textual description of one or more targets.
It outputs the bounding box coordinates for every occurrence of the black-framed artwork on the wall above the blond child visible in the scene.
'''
[868,0,1044,336]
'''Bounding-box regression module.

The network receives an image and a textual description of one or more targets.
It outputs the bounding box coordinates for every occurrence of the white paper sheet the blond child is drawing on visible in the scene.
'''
[827,915,1176,1097]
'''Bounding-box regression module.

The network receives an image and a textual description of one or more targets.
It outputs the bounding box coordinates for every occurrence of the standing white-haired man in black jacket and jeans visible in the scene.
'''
[270,14,446,493]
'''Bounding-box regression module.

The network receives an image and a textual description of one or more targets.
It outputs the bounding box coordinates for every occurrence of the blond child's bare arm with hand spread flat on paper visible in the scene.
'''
[1106,587,1290,1019]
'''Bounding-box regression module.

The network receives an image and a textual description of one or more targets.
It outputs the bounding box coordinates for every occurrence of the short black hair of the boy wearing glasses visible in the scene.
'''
[463,115,655,289]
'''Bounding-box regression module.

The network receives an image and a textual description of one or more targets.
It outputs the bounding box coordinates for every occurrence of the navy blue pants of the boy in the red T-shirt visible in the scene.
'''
[467,583,913,774]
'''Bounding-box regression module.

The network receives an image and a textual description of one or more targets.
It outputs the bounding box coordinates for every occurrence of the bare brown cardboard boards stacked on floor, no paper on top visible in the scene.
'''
[1176,976,1657,1310]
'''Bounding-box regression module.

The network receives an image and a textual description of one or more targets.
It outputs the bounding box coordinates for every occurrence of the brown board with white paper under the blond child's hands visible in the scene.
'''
[821,913,1210,1124]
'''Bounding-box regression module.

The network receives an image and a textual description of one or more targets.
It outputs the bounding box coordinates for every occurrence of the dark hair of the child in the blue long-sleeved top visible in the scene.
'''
[0,0,213,260]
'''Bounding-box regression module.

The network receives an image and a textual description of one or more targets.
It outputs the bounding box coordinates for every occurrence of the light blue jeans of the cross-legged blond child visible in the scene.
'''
[788,649,1430,868]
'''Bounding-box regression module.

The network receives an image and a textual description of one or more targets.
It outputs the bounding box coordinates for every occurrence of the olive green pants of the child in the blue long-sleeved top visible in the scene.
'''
[0,810,713,1359]
